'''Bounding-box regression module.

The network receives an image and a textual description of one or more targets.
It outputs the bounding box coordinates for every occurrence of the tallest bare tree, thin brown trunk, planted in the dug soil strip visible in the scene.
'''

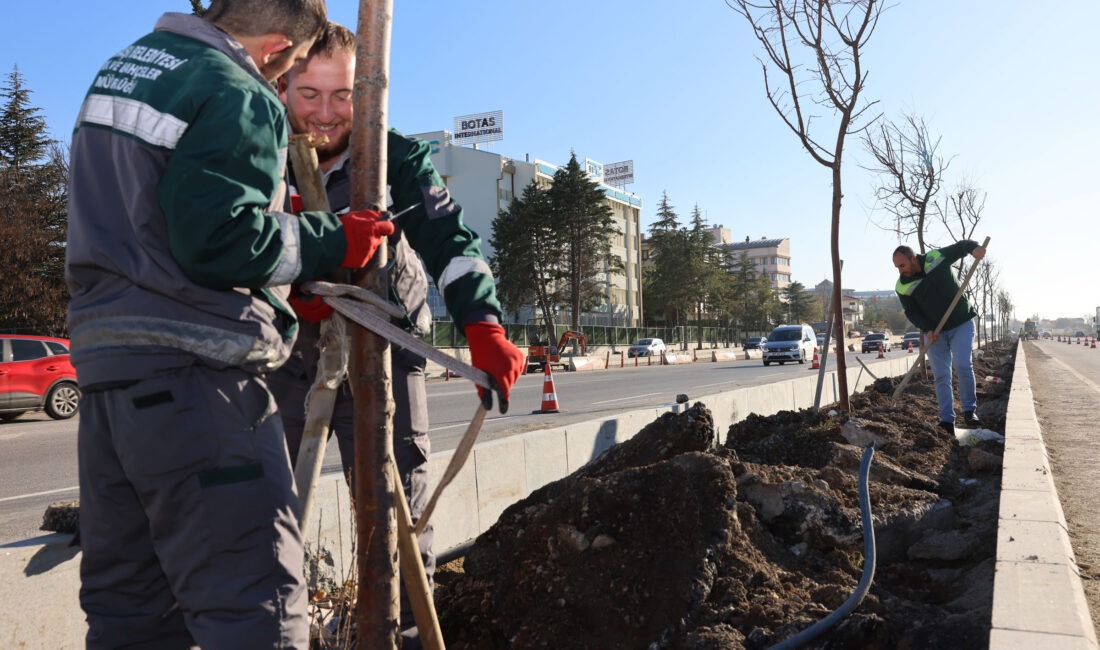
[726,0,883,411]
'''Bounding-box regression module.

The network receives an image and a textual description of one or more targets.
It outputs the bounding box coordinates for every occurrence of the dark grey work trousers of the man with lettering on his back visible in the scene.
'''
[77,365,309,650]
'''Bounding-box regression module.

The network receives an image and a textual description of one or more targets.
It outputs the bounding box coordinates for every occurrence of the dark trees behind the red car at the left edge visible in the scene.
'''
[0,67,68,335]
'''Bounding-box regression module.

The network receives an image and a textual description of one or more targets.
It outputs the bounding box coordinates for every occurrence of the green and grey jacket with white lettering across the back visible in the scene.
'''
[66,13,347,385]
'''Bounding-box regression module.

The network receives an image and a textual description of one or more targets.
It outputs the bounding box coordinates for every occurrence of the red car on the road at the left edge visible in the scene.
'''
[0,334,80,420]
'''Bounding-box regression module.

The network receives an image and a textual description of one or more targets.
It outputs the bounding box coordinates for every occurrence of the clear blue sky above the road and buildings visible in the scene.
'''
[0,0,1100,319]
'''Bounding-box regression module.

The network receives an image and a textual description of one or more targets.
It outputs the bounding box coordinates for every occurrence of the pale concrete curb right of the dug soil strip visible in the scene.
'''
[989,342,1097,650]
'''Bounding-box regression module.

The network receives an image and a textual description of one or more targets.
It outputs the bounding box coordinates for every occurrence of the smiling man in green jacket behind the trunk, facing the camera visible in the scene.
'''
[268,22,524,648]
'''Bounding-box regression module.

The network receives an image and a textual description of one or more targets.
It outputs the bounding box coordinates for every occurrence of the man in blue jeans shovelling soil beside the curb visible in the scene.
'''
[893,240,986,434]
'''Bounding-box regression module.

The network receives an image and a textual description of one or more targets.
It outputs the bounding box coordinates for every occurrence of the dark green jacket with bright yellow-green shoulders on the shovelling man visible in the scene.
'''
[895,240,978,332]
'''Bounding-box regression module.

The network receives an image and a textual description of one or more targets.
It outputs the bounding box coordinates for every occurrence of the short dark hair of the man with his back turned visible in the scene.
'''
[202,0,328,43]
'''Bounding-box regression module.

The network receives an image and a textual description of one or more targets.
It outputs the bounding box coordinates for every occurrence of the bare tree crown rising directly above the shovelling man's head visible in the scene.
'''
[864,114,950,254]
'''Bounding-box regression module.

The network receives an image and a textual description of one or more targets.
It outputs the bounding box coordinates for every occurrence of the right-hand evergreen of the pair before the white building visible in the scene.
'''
[549,154,623,330]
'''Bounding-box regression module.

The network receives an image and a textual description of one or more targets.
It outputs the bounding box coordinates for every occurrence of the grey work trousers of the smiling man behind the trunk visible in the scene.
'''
[268,345,436,627]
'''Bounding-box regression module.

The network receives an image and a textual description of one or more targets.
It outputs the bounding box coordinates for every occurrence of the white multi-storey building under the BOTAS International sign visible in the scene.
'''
[414,131,642,326]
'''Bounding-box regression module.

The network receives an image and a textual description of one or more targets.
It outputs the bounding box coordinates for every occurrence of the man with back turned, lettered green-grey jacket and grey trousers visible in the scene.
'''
[65,0,394,650]
